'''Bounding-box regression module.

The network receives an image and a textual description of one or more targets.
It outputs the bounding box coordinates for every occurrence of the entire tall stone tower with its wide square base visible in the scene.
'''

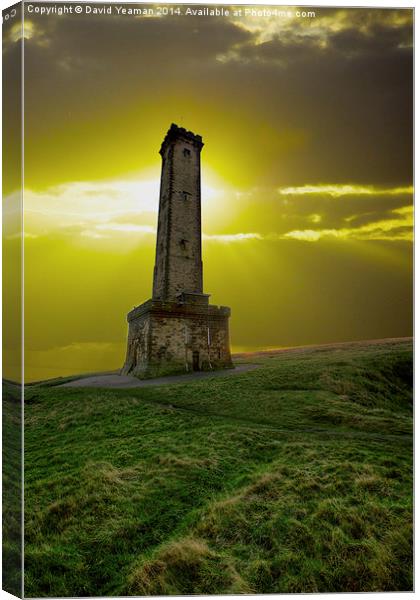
[122,124,233,378]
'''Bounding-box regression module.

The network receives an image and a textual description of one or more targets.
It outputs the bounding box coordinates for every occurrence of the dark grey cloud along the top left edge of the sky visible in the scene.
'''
[26,10,251,79]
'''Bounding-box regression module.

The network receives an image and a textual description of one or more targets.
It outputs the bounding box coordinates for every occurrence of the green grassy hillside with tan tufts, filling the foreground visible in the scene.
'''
[25,341,412,597]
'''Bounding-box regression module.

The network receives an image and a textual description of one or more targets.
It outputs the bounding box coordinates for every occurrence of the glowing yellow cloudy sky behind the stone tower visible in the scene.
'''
[3,5,413,381]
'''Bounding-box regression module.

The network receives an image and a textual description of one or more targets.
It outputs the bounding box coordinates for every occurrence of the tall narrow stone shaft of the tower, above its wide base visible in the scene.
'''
[153,123,208,303]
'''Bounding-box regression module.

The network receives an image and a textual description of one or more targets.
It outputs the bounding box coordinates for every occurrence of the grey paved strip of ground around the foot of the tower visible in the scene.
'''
[58,365,261,388]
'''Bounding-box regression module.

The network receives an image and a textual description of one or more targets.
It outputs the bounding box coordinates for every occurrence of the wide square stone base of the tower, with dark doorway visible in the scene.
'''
[121,294,233,379]
